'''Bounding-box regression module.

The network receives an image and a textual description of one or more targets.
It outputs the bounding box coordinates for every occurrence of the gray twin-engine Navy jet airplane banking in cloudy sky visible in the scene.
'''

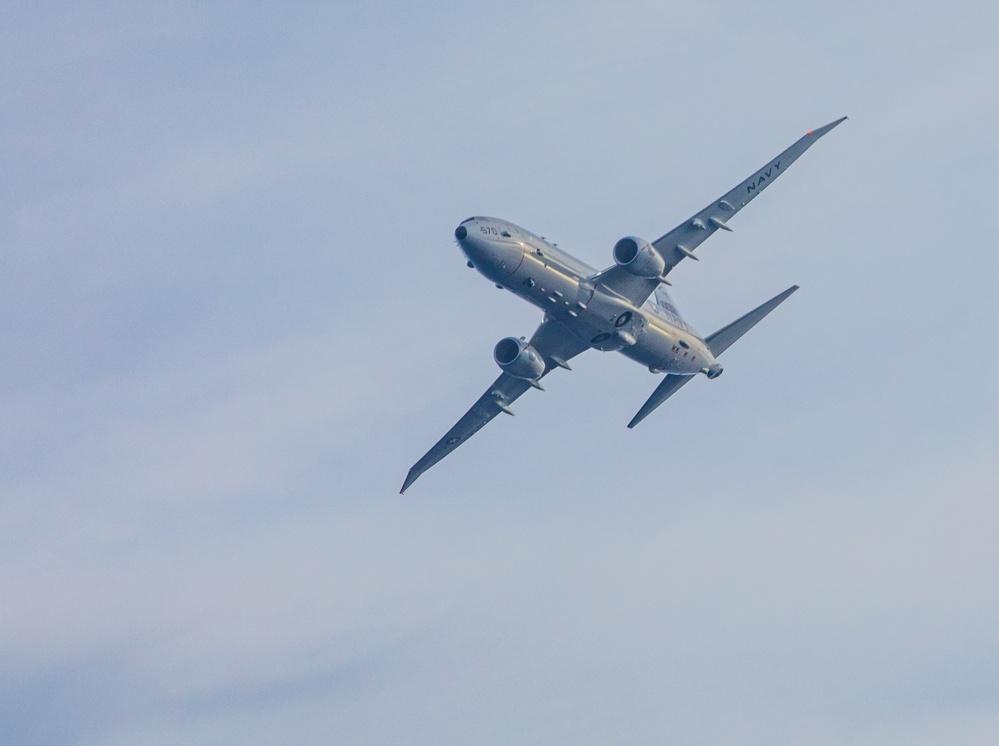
[399,117,846,494]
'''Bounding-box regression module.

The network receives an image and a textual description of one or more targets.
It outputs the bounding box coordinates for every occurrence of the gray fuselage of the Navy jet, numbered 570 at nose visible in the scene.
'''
[455,217,715,375]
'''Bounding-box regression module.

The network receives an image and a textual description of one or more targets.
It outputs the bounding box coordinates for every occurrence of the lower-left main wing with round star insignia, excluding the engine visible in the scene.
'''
[399,317,589,494]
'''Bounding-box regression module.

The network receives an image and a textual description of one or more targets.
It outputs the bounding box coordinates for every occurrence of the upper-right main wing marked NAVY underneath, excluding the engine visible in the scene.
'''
[593,117,846,306]
